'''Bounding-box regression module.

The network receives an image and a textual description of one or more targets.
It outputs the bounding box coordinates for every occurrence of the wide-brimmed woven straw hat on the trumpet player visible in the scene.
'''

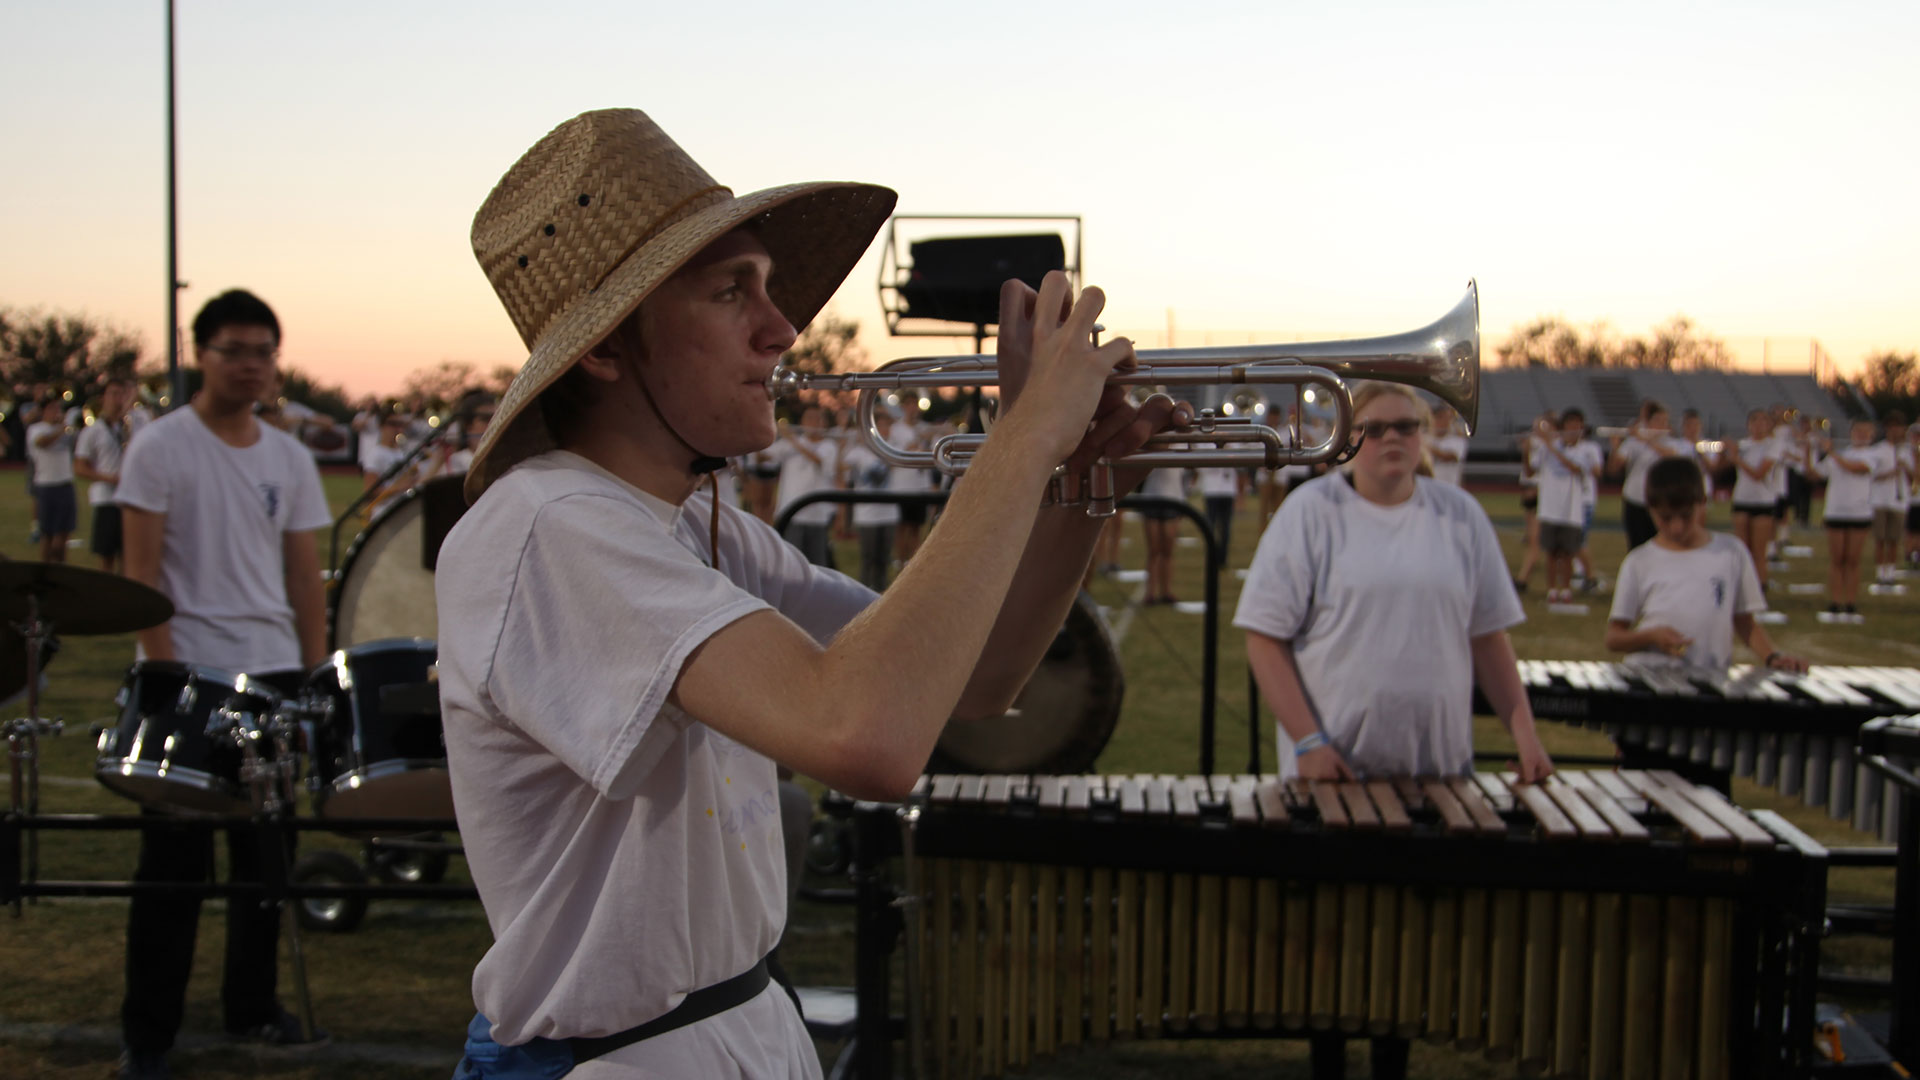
[467,110,895,502]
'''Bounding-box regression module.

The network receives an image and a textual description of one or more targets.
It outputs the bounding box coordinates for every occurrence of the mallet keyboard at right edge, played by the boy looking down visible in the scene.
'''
[1521,659,1920,842]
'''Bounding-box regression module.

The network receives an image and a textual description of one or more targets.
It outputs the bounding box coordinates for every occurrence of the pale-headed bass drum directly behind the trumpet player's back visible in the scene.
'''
[326,477,467,650]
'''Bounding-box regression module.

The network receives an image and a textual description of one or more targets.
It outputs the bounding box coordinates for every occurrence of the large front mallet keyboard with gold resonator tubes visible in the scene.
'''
[854,773,1826,1080]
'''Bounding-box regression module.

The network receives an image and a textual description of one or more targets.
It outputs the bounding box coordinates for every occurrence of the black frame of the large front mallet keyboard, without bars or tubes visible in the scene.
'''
[852,787,1826,1080]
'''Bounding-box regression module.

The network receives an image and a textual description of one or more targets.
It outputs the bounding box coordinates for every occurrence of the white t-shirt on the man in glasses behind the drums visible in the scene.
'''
[113,407,332,671]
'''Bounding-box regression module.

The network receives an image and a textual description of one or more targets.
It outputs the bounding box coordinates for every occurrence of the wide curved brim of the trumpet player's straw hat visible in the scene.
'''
[463,181,899,503]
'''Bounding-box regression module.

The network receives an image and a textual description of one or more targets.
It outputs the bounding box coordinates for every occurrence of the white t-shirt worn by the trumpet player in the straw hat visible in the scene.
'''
[436,450,874,1076]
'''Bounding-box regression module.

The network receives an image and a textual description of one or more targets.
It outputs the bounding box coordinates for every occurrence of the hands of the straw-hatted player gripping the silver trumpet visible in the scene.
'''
[996,271,1192,494]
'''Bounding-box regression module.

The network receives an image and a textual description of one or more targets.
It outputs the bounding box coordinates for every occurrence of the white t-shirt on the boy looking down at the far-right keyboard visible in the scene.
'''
[1607,532,1766,673]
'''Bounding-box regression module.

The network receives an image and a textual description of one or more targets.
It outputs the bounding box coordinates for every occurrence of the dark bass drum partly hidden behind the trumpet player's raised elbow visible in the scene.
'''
[927,592,1127,774]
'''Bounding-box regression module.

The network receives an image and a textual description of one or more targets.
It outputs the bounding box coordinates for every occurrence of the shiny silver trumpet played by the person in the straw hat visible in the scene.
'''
[766,281,1480,517]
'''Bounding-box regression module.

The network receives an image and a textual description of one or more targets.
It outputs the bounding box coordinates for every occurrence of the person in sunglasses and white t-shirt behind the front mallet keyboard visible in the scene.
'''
[1233,382,1553,1080]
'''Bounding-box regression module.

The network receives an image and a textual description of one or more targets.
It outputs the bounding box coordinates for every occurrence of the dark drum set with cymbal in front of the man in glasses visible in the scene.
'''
[0,561,470,930]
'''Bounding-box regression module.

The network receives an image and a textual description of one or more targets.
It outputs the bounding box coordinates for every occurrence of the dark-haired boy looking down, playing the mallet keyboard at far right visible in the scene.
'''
[1607,457,1807,675]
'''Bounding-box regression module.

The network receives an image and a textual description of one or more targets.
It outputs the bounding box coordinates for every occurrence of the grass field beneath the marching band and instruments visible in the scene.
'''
[0,473,1920,1080]
